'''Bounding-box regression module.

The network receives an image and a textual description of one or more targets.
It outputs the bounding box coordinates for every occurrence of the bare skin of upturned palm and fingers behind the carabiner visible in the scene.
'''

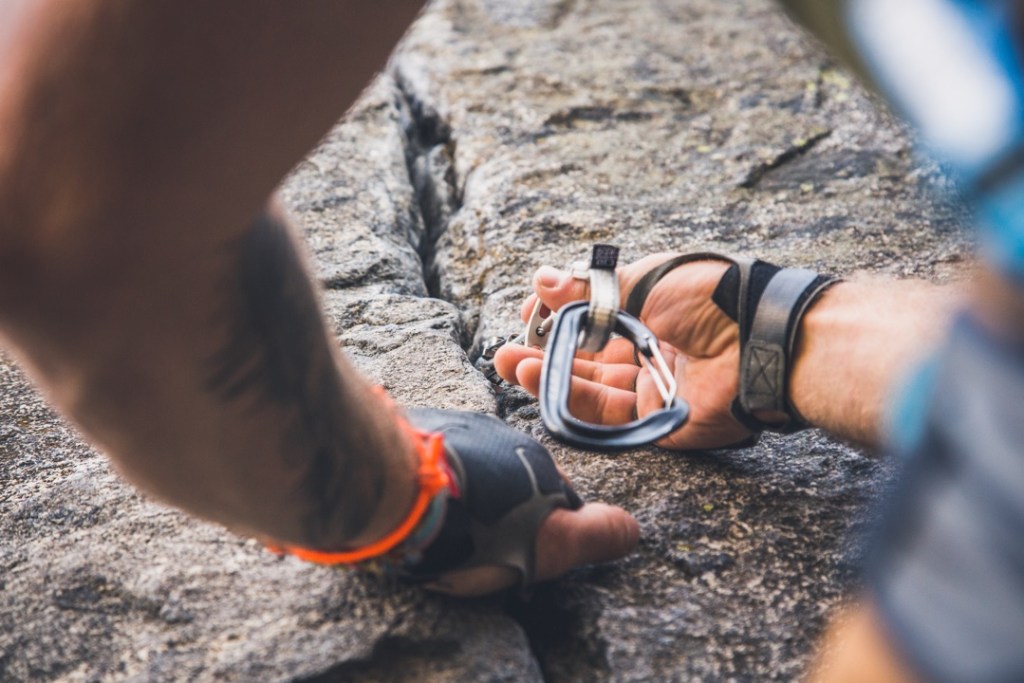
[495,254,751,450]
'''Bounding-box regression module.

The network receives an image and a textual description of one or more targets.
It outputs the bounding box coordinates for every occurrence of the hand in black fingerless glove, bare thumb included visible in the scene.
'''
[408,409,639,596]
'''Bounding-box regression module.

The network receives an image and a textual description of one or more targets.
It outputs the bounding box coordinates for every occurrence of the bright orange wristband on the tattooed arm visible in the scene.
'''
[267,405,452,564]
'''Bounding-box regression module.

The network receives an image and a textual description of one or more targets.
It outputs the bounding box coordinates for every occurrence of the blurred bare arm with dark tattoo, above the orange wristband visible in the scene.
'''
[0,0,419,548]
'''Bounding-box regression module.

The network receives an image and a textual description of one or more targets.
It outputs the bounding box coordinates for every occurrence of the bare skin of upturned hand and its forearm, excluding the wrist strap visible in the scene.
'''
[495,254,963,450]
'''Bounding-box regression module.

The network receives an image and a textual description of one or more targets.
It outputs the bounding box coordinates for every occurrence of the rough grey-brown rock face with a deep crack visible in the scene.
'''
[0,0,969,681]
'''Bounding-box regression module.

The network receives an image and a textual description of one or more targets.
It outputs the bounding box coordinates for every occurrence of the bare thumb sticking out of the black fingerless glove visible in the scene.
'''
[537,503,640,581]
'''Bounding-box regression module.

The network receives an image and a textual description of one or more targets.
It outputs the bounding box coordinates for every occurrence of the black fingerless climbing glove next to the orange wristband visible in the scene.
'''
[402,408,583,587]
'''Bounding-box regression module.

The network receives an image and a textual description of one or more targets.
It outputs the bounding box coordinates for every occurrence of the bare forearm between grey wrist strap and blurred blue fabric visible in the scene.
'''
[791,278,966,445]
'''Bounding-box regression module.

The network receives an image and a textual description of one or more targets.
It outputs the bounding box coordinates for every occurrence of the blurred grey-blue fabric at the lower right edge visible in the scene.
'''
[867,317,1024,682]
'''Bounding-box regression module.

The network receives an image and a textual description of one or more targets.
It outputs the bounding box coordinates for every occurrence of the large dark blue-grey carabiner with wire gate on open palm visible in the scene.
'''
[540,301,689,450]
